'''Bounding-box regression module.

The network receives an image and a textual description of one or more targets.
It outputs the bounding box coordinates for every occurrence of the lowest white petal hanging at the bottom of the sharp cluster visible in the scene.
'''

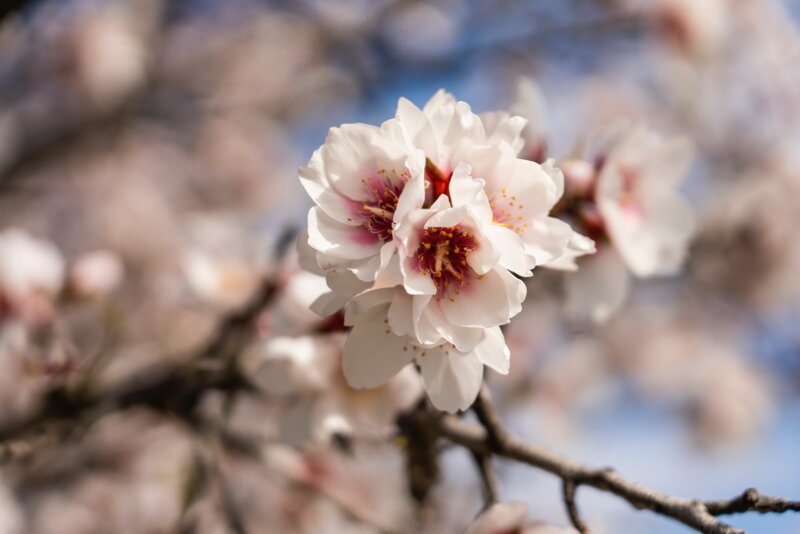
[416,345,483,413]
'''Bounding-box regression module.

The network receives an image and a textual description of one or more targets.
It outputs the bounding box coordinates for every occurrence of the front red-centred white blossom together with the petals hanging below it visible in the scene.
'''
[344,164,526,412]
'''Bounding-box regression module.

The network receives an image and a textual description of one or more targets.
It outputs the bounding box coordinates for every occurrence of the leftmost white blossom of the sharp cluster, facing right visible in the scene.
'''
[300,120,424,289]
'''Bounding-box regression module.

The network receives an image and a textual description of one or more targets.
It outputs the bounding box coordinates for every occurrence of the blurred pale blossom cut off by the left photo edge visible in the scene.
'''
[0,228,64,319]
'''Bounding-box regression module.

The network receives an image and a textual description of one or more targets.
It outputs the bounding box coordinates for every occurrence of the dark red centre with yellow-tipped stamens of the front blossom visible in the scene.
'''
[415,225,478,300]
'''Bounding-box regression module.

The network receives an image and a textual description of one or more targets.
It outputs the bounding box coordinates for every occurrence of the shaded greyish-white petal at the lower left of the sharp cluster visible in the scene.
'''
[342,313,413,389]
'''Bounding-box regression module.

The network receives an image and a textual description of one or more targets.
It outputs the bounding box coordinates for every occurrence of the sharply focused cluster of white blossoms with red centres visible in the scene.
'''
[298,91,594,412]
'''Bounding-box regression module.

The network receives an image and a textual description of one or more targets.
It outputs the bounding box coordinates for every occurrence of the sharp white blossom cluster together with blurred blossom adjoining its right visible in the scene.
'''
[298,87,692,412]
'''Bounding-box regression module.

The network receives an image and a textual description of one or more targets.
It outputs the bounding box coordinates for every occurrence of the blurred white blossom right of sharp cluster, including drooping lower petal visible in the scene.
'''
[566,126,694,321]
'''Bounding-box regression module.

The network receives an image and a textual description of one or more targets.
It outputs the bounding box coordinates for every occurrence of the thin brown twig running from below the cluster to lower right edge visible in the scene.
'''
[429,389,800,534]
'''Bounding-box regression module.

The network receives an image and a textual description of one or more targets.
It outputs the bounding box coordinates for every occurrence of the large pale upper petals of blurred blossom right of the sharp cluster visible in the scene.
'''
[596,126,694,278]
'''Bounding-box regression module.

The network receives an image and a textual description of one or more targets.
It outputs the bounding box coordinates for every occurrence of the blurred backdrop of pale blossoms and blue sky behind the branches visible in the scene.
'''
[0,0,800,534]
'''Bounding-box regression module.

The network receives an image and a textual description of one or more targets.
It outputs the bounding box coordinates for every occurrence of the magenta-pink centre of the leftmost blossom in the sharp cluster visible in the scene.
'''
[353,169,409,241]
